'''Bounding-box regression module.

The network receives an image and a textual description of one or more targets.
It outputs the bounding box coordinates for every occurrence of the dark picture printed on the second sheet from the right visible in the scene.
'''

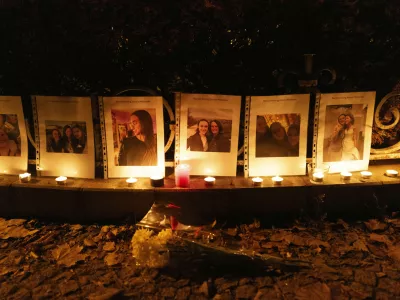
[256,114,300,157]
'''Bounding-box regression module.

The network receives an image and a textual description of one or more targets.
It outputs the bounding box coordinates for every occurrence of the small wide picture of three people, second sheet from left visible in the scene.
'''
[45,121,88,154]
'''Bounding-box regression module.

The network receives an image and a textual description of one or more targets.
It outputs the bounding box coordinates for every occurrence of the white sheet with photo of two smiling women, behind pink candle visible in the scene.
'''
[175,94,241,176]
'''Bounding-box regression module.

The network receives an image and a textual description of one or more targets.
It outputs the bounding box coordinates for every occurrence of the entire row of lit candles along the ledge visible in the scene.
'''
[14,168,399,188]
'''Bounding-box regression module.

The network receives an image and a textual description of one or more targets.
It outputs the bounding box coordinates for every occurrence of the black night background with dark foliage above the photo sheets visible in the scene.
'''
[0,0,400,166]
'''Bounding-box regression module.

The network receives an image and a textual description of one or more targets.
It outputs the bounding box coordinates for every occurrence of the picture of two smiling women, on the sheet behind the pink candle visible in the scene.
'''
[186,108,233,153]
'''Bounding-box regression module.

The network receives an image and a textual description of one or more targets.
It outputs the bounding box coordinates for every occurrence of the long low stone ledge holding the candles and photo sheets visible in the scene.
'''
[0,164,400,223]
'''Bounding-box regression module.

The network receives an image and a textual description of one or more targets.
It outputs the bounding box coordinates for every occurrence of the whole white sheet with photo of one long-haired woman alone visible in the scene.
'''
[103,96,165,178]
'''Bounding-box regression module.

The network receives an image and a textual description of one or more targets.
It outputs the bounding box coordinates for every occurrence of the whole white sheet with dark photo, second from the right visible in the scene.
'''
[248,94,310,176]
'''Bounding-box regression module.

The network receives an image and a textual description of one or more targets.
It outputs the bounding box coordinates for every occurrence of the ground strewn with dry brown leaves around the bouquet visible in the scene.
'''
[0,218,400,300]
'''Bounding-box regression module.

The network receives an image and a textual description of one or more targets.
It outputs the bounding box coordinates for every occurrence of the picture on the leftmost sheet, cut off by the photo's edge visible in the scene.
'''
[0,114,21,156]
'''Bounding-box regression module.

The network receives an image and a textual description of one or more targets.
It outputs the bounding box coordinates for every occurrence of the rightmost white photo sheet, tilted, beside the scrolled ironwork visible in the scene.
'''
[316,92,375,173]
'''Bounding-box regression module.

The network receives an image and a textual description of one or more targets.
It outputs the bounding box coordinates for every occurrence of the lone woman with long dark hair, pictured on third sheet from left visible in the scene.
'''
[118,110,157,166]
